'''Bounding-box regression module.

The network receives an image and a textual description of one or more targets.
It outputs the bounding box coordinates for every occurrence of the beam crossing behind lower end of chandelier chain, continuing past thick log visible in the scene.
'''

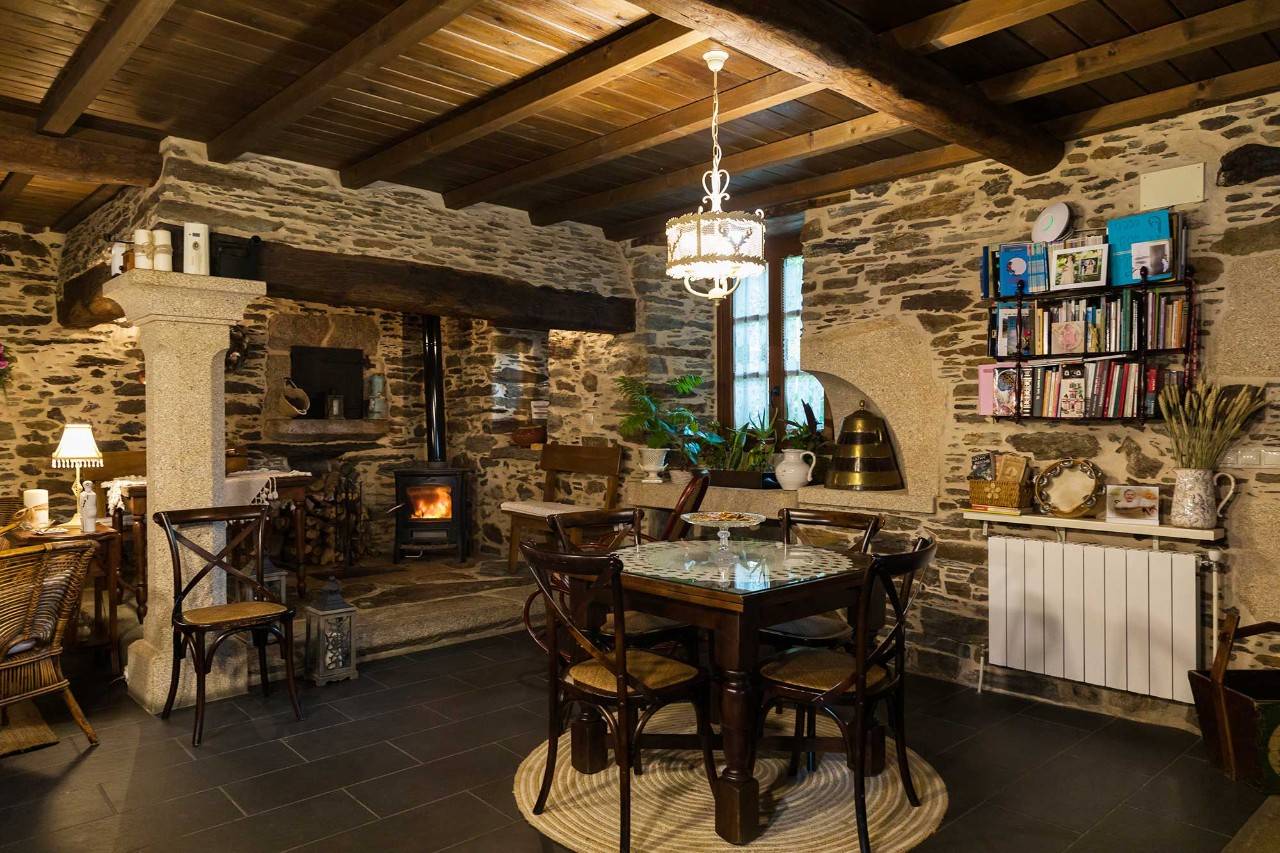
[542,0,1280,225]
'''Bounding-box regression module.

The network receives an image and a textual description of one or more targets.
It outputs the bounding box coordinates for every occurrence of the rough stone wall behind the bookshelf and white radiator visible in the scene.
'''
[804,95,1280,706]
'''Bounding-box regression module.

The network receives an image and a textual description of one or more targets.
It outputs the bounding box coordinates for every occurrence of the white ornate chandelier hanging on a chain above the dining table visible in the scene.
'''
[667,50,764,301]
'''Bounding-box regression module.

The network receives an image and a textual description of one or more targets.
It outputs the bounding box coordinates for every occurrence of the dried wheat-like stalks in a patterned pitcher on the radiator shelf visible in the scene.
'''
[1160,379,1267,530]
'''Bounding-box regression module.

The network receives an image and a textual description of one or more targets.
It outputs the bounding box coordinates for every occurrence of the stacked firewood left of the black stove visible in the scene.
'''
[275,466,374,566]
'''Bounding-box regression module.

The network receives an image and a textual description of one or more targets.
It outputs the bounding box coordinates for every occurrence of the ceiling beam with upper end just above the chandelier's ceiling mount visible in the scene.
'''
[342,19,705,187]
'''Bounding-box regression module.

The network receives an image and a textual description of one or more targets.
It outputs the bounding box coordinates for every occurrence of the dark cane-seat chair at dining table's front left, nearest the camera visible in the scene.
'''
[520,542,716,853]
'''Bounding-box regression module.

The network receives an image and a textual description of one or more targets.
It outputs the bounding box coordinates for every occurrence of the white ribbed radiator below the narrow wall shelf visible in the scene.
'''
[987,537,1199,702]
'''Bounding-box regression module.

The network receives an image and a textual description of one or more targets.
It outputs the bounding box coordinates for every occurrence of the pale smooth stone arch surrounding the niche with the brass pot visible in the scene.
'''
[800,318,948,512]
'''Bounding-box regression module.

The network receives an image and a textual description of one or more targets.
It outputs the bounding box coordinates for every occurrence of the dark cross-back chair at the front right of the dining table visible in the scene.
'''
[760,538,937,853]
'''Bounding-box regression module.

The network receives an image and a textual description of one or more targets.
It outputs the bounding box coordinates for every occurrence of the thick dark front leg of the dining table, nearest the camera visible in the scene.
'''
[716,616,760,844]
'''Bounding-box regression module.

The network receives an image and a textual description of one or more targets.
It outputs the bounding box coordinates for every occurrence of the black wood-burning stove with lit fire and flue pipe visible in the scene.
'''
[393,316,471,562]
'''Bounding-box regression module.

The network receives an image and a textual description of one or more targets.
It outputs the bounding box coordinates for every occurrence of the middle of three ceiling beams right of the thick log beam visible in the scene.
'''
[980,0,1280,102]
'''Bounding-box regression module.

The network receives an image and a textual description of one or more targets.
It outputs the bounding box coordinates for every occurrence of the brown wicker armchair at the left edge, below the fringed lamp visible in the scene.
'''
[0,542,97,744]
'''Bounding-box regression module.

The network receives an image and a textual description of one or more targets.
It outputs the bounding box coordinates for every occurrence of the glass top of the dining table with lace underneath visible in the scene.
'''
[616,539,863,596]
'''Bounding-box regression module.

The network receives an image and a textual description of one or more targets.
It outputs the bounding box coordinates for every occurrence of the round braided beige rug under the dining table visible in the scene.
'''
[515,704,947,853]
